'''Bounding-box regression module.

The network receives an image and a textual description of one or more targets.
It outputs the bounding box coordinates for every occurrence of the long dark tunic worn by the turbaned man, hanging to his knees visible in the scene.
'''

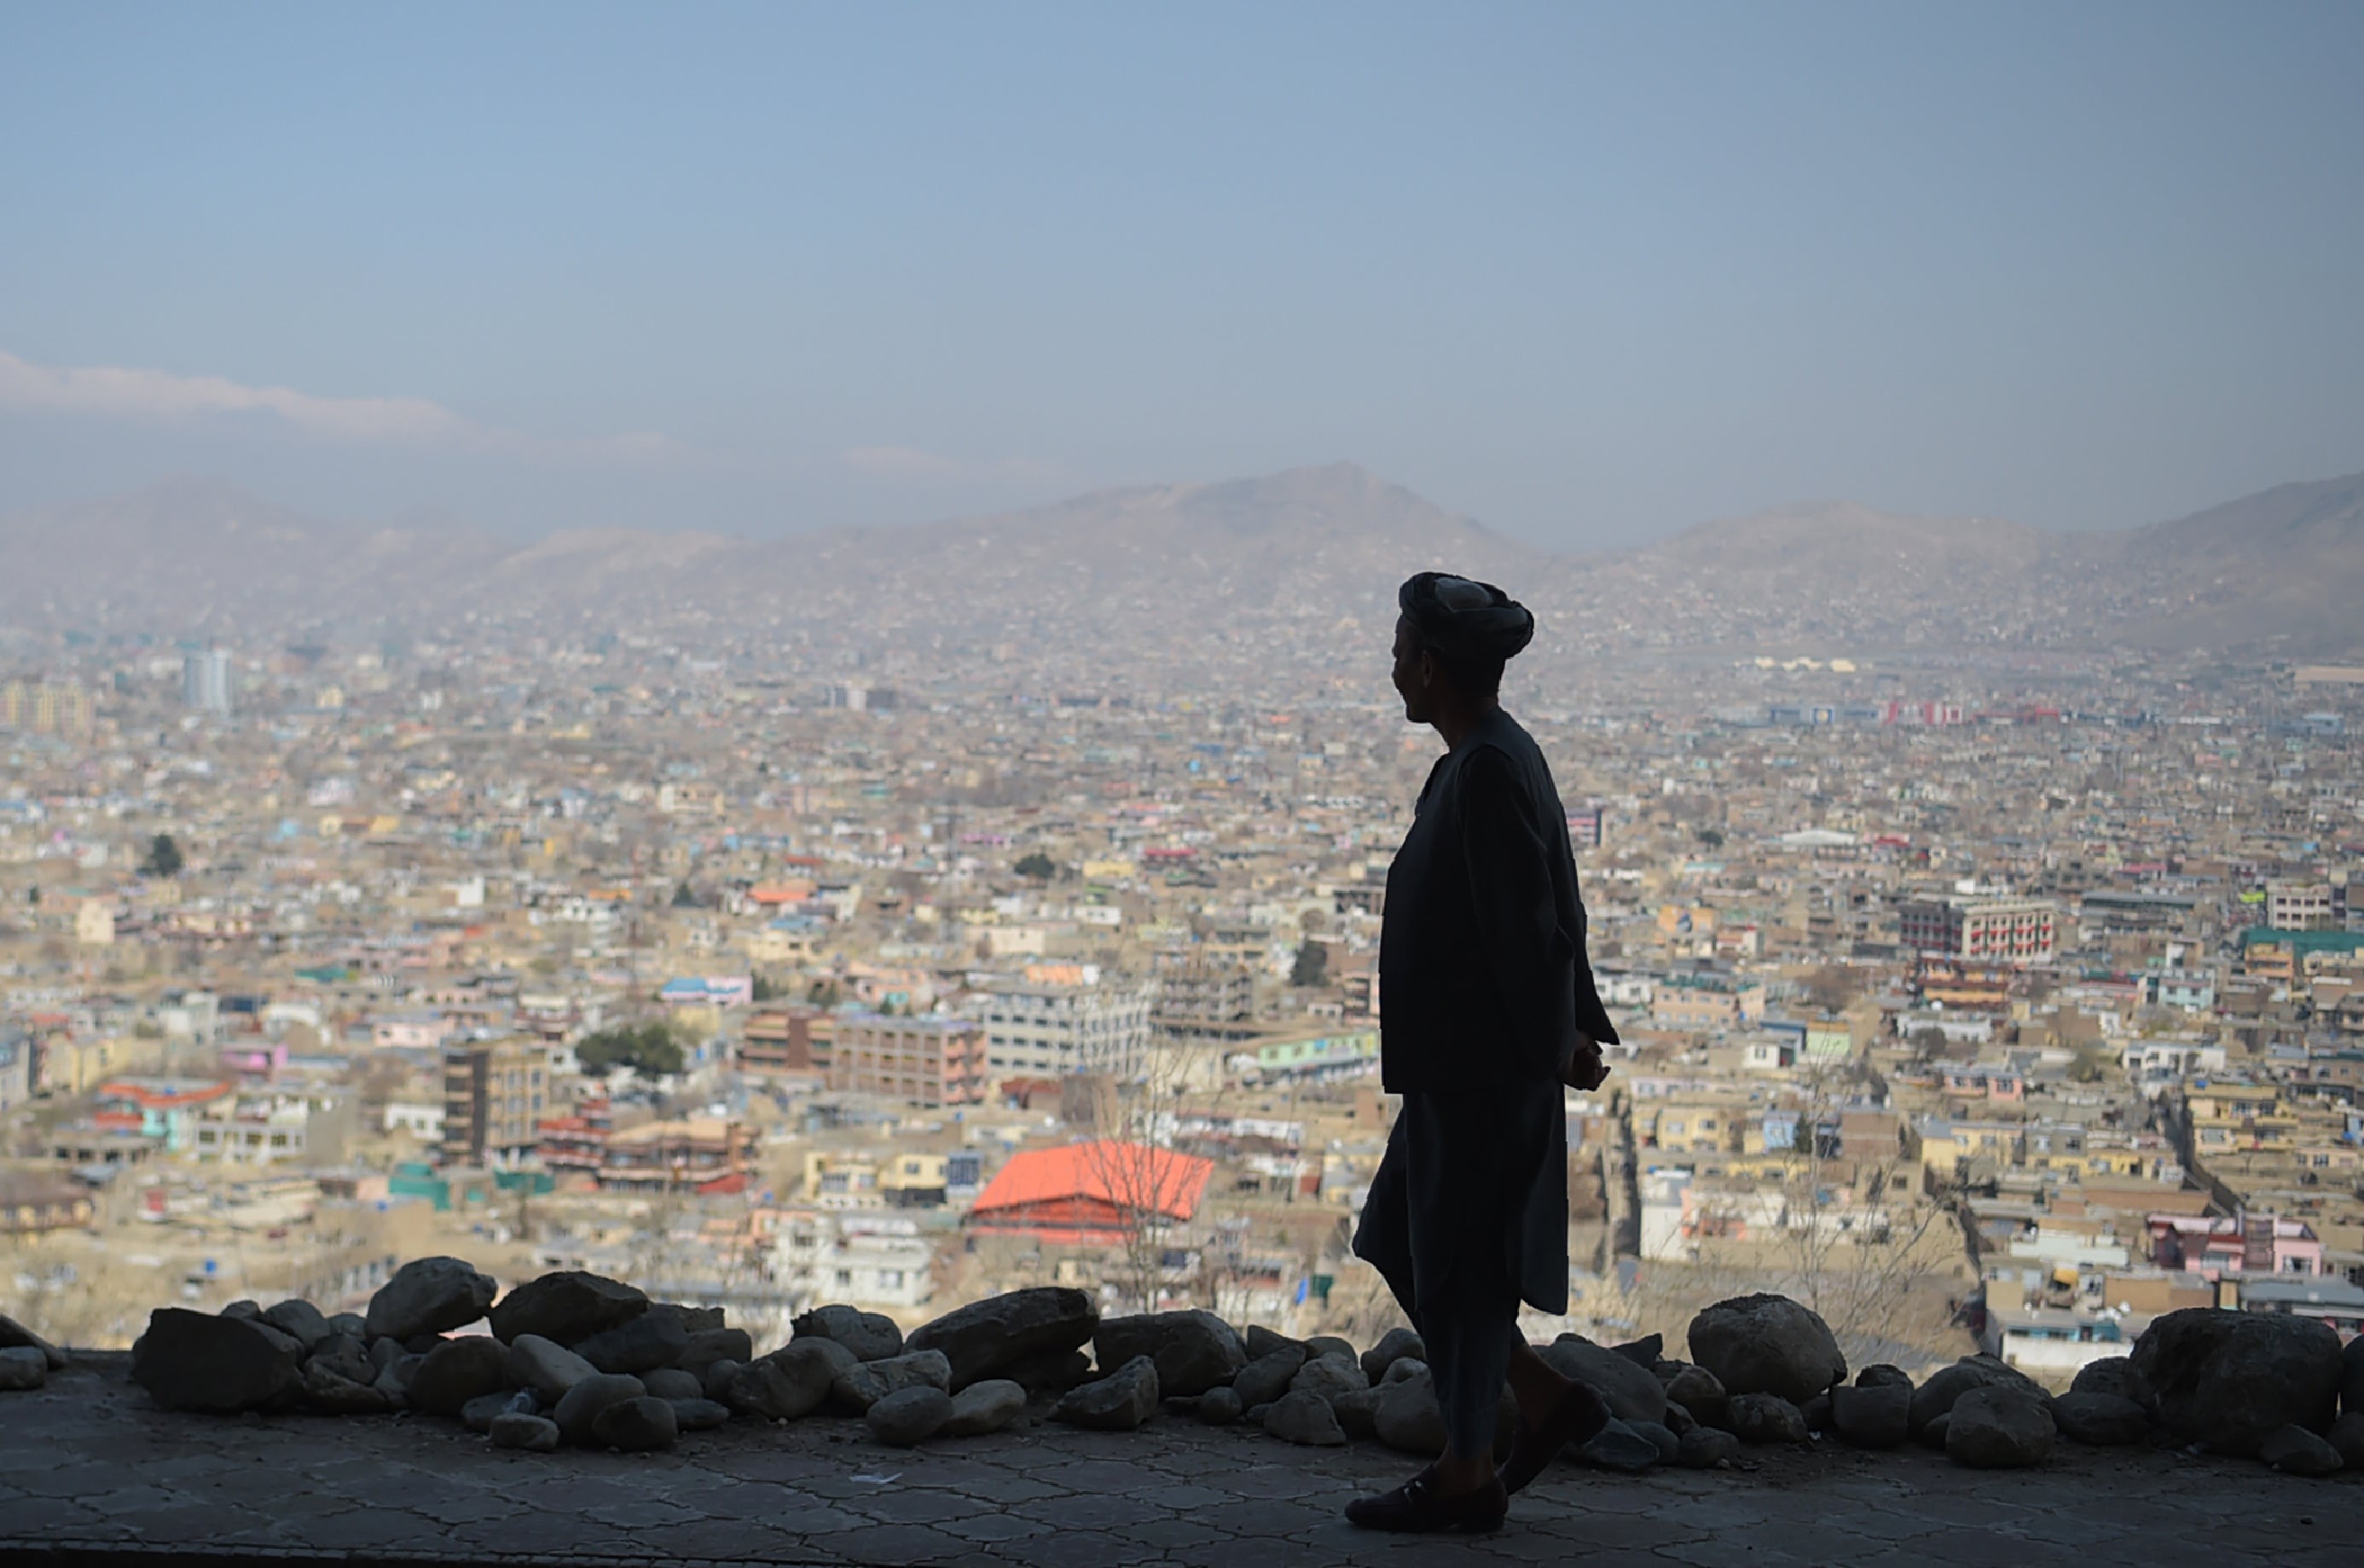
[1357,709,1617,1312]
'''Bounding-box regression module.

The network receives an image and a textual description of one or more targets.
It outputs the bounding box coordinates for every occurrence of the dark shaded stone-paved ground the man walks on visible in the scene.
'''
[0,1355,2364,1568]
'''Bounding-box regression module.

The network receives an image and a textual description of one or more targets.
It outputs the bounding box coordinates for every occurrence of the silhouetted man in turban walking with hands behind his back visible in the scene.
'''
[1347,572,1617,1530]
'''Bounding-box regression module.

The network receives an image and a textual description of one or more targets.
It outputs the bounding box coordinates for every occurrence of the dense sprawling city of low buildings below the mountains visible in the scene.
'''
[0,567,2364,1386]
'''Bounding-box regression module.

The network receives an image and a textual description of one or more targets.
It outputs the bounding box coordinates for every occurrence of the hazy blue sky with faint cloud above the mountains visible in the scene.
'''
[0,0,2364,547]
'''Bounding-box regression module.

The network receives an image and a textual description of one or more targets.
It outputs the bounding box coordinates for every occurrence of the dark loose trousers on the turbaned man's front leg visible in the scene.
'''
[1354,1095,1518,1457]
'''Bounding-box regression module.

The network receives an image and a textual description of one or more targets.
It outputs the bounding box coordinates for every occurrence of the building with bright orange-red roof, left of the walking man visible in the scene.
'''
[967,1137,1215,1247]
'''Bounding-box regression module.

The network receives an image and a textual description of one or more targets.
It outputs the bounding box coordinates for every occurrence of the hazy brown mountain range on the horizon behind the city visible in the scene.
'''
[0,464,2364,662]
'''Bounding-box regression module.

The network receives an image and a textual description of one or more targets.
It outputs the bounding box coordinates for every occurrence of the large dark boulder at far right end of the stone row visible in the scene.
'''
[2130,1308,2345,1455]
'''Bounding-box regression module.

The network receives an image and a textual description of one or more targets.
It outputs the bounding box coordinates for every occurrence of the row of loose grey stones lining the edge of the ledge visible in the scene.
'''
[73,1258,2364,1476]
